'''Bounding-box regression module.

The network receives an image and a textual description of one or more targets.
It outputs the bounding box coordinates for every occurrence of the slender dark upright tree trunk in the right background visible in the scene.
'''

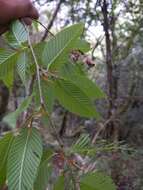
[101,0,119,140]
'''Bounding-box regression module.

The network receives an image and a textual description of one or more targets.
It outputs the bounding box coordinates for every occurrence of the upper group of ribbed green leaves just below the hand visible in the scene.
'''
[0,23,105,121]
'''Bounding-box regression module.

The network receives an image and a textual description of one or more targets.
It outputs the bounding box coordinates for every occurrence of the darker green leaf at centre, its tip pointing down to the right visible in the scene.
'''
[54,79,99,118]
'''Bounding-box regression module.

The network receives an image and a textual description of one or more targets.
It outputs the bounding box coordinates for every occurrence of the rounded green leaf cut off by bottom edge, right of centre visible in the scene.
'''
[80,172,116,190]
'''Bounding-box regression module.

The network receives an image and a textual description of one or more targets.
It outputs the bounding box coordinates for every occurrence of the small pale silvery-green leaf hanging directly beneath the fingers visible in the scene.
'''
[11,20,28,46]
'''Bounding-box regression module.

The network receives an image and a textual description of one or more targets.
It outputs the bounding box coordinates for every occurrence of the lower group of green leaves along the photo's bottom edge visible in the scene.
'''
[0,131,116,190]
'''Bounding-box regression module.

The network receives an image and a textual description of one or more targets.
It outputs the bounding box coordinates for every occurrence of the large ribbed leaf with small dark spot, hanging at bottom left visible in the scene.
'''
[7,128,42,190]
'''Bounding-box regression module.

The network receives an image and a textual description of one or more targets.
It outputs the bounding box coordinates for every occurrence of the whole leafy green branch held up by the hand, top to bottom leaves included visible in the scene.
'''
[0,21,115,190]
